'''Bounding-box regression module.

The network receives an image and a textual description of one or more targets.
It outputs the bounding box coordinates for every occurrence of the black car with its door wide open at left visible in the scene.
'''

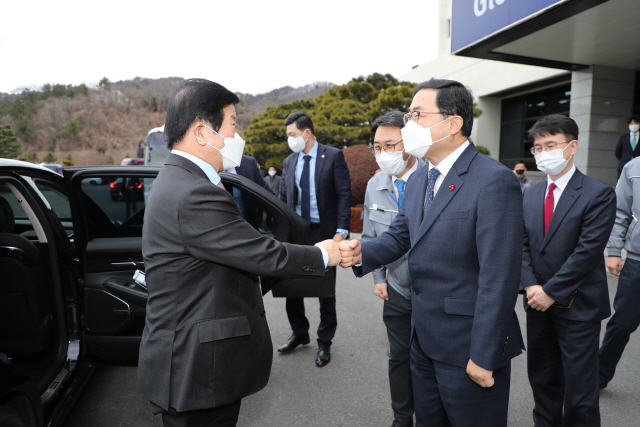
[0,159,333,427]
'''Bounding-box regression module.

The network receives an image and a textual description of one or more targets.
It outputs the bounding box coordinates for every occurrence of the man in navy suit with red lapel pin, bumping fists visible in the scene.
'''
[340,79,524,427]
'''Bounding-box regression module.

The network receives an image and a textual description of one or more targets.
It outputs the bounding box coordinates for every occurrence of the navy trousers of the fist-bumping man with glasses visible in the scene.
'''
[411,334,511,427]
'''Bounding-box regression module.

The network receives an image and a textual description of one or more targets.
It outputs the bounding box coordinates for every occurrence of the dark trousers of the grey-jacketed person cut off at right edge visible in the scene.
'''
[600,258,640,385]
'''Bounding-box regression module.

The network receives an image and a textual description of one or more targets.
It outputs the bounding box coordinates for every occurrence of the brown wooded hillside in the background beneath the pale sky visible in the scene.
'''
[0,77,332,166]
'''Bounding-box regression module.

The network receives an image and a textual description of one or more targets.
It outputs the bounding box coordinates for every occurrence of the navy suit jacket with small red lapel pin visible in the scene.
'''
[354,143,524,370]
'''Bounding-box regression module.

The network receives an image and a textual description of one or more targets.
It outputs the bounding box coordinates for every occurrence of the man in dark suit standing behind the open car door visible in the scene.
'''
[278,111,351,368]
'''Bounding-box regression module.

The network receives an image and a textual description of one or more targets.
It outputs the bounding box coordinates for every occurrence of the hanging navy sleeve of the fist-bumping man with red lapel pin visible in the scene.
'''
[470,168,523,370]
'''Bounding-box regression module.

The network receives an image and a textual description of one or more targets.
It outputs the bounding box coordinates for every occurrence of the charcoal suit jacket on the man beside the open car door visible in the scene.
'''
[138,154,324,411]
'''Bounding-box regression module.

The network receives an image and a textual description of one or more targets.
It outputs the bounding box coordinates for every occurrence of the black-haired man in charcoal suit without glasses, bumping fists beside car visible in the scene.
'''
[138,79,339,427]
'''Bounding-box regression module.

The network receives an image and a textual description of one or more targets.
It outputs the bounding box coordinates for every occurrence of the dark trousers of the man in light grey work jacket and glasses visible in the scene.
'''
[382,286,413,427]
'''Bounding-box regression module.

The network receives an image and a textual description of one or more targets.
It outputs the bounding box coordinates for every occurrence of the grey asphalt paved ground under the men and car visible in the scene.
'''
[67,252,640,427]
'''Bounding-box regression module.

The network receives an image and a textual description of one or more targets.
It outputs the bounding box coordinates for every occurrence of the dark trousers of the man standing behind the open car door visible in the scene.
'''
[285,228,338,346]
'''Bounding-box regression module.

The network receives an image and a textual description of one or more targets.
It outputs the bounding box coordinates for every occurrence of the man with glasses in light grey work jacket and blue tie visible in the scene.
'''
[362,111,425,427]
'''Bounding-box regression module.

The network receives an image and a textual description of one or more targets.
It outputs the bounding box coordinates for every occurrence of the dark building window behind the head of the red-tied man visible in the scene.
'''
[500,84,571,170]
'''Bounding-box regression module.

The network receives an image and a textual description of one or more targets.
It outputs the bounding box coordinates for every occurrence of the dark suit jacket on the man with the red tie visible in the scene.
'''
[520,169,616,322]
